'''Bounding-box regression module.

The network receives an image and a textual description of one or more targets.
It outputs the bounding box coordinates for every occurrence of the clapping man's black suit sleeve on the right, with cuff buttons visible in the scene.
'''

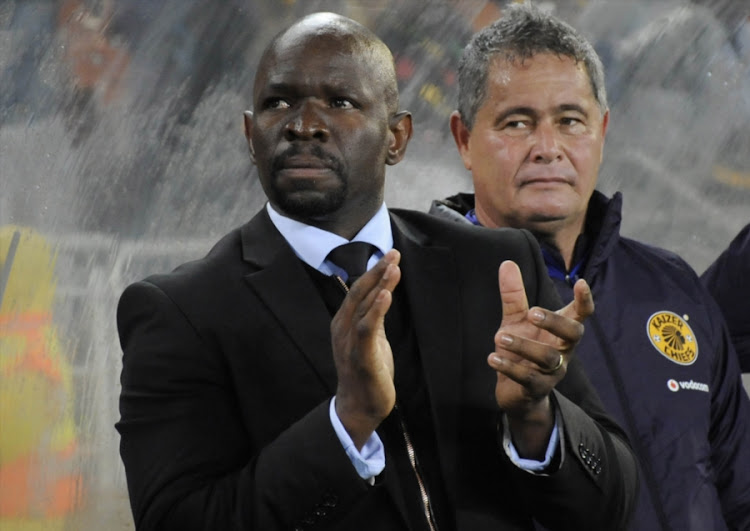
[506,231,638,530]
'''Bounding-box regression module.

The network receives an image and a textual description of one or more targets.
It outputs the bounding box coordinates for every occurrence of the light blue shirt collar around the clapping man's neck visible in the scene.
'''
[266,203,393,275]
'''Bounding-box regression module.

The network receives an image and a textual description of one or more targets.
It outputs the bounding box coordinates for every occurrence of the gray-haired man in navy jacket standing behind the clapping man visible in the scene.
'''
[431,4,750,530]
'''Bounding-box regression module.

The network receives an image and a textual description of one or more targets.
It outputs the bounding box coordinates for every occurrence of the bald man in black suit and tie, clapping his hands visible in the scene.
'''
[117,13,637,531]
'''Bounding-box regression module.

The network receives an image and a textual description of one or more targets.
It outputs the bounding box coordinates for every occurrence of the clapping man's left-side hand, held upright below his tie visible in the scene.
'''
[331,249,401,450]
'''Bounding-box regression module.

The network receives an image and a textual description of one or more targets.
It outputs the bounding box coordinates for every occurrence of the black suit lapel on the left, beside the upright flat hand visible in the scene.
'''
[241,209,336,394]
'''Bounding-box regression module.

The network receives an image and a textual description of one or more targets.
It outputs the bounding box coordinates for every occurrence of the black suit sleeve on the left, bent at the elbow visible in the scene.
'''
[116,282,377,531]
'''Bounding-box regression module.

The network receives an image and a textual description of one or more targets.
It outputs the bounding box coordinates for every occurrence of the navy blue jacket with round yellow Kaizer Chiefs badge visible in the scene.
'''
[430,192,750,531]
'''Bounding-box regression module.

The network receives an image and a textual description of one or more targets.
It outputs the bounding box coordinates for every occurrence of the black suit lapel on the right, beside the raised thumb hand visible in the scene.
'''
[391,215,462,499]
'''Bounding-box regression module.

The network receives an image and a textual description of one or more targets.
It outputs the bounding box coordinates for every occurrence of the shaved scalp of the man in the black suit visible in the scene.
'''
[254,13,398,112]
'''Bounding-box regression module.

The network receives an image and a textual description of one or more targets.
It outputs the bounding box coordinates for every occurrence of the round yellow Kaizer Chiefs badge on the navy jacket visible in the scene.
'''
[646,312,698,365]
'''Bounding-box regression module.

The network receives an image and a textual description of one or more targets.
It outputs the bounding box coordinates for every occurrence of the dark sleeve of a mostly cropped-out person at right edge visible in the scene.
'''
[701,224,750,372]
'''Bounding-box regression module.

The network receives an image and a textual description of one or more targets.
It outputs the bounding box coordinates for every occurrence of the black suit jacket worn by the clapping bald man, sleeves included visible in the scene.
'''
[117,209,637,531]
